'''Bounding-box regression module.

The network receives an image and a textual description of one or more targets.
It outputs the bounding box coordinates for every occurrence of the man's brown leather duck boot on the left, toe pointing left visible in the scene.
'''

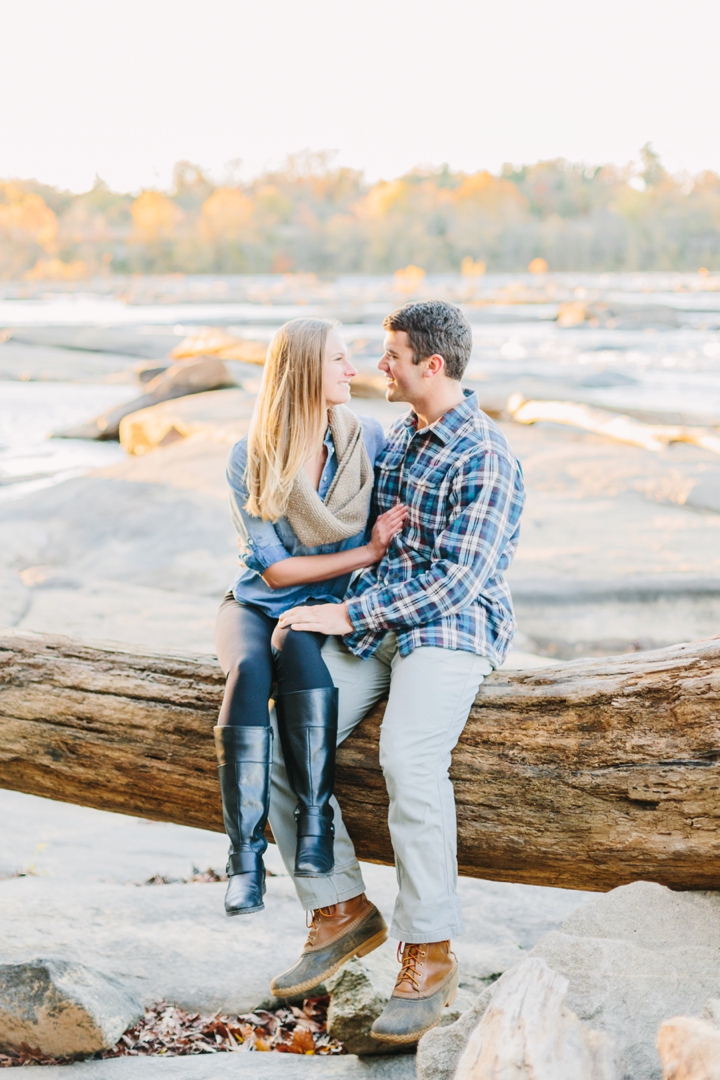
[270,892,388,998]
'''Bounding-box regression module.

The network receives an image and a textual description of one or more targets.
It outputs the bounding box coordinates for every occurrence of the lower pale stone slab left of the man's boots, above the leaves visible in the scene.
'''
[0,877,307,1013]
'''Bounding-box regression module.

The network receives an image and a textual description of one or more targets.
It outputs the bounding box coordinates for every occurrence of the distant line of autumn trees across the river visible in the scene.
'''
[0,145,720,280]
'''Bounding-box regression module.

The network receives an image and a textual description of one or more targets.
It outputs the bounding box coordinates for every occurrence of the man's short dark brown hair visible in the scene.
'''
[382,300,473,381]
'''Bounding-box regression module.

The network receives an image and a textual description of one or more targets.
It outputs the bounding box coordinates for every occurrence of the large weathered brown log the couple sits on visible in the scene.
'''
[0,632,720,890]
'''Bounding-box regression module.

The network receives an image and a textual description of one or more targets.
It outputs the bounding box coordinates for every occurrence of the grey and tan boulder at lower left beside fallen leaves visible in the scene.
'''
[0,959,142,1056]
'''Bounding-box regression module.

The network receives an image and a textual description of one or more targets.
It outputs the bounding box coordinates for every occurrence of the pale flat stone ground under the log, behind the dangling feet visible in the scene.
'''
[0,791,592,1011]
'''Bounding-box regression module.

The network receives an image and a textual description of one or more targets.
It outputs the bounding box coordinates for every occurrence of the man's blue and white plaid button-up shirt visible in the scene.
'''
[344,390,525,667]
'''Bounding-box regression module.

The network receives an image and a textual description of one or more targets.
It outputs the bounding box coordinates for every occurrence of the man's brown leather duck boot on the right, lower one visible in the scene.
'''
[370,942,459,1044]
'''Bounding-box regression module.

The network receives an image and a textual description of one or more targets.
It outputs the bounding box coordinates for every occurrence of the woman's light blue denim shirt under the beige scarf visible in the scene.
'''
[227,417,385,618]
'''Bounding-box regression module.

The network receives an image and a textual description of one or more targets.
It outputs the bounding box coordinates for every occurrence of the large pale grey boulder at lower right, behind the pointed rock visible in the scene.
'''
[418,881,720,1080]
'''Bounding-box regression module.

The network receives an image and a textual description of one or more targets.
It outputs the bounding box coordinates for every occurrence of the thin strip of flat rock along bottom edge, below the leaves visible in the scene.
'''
[33,1052,416,1080]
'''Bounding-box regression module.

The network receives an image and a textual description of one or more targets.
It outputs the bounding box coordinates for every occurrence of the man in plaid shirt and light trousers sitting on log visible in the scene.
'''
[264,301,524,1044]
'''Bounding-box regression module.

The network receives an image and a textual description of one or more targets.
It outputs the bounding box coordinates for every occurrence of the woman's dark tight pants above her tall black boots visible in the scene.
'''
[215,593,334,727]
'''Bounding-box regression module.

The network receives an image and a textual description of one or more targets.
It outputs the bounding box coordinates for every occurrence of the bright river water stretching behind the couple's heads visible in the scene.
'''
[0,274,720,500]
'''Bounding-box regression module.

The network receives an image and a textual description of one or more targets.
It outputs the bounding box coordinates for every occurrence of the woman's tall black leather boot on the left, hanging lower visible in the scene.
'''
[215,725,273,915]
